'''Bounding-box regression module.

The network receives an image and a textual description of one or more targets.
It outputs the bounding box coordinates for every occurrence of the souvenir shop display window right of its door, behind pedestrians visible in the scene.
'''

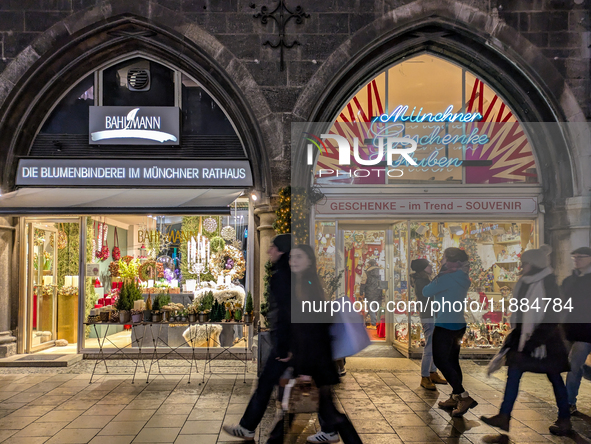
[394,221,538,355]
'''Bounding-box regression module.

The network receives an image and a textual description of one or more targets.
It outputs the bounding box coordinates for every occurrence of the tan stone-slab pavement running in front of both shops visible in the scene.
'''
[0,358,591,444]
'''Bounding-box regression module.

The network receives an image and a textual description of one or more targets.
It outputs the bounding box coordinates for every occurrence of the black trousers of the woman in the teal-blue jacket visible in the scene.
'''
[433,326,466,395]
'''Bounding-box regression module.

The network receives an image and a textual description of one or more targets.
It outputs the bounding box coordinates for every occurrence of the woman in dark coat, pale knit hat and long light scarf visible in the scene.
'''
[481,245,572,436]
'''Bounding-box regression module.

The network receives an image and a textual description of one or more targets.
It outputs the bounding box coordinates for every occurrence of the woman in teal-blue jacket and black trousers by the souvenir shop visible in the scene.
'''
[423,247,478,416]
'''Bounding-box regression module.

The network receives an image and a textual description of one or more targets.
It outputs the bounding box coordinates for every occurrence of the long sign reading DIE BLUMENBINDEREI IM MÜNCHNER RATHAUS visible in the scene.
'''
[16,159,253,188]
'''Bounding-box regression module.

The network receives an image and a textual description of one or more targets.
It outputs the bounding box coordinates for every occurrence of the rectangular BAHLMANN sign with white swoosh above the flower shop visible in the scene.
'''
[88,106,180,145]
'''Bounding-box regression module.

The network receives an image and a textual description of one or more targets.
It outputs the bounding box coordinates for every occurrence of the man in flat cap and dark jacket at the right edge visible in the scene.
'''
[562,247,591,415]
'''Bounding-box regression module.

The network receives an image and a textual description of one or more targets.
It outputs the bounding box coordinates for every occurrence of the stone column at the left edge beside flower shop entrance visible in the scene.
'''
[0,217,18,358]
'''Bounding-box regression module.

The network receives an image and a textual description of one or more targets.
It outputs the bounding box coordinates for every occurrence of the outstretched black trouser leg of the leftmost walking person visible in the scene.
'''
[240,353,289,431]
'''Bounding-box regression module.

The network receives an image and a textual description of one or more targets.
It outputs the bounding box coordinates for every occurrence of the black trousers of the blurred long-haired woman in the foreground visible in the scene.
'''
[267,386,362,444]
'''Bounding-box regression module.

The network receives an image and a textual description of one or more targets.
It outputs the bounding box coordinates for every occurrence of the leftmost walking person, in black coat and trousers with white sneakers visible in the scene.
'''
[223,234,291,441]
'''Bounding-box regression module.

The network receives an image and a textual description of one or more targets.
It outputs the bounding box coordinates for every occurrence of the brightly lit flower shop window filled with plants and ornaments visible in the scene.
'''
[79,205,252,351]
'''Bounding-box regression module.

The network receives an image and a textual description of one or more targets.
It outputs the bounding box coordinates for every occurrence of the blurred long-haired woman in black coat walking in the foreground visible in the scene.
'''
[289,245,361,444]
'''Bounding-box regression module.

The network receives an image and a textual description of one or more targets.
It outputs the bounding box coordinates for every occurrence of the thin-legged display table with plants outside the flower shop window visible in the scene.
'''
[84,322,252,384]
